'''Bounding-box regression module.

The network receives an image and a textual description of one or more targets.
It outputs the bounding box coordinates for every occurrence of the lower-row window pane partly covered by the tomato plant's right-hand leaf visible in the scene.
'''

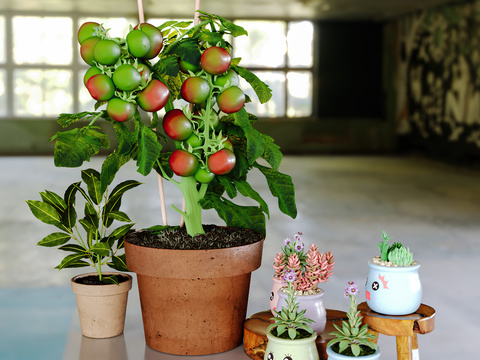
[240,71,285,117]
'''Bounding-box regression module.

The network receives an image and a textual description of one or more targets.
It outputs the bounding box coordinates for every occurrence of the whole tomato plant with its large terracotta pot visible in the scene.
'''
[47,12,297,355]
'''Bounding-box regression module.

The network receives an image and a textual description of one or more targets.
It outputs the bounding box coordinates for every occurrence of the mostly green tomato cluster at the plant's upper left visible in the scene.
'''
[78,22,170,122]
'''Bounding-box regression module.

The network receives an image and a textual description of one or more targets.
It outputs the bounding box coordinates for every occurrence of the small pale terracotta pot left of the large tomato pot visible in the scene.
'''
[71,273,132,339]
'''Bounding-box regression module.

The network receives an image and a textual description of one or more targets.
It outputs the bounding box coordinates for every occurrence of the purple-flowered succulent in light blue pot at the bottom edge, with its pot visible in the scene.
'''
[327,281,380,360]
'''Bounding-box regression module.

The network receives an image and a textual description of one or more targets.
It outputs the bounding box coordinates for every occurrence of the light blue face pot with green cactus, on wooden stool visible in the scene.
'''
[365,231,422,315]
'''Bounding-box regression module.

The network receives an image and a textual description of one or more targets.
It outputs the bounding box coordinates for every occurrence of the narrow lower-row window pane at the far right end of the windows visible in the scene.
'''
[287,71,312,117]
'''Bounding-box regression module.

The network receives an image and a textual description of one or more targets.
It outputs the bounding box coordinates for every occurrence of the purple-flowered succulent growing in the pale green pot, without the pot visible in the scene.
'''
[267,270,313,340]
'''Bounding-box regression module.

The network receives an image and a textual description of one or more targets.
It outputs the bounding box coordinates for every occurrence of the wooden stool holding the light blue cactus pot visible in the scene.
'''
[358,302,435,360]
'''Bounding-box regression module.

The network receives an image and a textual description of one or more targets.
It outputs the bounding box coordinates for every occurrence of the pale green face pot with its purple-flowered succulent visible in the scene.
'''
[264,270,319,360]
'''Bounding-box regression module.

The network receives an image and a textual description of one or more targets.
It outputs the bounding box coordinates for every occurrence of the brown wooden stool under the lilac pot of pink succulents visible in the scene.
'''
[243,309,348,360]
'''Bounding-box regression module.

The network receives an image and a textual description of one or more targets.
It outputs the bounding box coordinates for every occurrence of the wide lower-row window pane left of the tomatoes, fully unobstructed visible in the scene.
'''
[13,69,73,116]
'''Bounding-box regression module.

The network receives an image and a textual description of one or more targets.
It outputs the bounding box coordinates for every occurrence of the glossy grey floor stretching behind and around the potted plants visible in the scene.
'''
[0,157,480,360]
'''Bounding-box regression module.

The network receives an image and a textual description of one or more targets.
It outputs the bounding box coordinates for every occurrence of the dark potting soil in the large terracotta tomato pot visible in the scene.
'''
[125,225,262,250]
